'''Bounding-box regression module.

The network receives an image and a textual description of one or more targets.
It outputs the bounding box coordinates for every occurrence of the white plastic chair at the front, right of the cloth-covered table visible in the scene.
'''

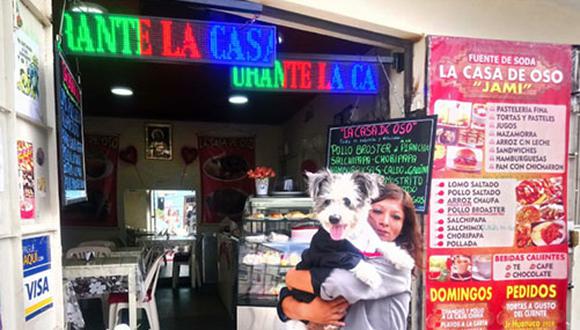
[109,254,164,330]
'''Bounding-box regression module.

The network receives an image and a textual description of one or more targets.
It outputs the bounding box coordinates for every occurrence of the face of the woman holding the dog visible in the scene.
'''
[369,199,405,242]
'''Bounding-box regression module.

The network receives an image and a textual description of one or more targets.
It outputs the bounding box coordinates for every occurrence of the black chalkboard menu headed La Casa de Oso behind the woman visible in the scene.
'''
[326,116,436,213]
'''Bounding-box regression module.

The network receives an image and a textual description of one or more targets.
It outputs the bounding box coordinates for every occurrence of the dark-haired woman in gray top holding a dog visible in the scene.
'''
[279,183,423,330]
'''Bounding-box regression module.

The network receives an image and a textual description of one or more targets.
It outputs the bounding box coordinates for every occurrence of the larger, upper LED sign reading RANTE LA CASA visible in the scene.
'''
[63,12,276,67]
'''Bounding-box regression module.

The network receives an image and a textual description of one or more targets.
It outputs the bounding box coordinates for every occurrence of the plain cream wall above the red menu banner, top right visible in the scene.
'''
[256,0,580,44]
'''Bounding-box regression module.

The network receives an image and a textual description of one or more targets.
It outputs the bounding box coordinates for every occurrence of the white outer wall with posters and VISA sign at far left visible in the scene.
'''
[0,0,64,330]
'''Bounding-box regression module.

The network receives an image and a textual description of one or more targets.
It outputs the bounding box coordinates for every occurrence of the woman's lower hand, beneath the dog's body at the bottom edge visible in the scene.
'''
[282,297,348,327]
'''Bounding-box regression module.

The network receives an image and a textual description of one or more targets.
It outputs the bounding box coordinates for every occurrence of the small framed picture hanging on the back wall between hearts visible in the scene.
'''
[145,124,173,160]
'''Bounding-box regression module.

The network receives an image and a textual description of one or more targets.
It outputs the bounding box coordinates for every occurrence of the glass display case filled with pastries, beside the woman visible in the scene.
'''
[237,196,318,306]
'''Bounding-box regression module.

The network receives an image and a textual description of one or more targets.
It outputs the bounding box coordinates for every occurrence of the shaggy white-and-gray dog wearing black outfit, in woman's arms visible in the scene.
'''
[285,170,414,330]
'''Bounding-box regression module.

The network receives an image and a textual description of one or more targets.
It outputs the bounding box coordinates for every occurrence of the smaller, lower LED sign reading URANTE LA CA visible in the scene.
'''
[230,59,379,94]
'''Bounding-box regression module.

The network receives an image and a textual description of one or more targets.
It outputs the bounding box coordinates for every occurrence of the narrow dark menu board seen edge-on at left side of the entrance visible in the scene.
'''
[57,53,87,205]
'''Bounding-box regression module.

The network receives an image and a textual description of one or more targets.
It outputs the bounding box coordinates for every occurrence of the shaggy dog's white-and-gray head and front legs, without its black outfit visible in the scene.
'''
[307,170,414,288]
